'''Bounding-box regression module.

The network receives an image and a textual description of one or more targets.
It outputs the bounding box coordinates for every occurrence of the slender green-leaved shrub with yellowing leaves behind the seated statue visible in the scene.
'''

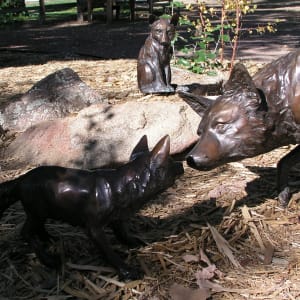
[173,0,276,75]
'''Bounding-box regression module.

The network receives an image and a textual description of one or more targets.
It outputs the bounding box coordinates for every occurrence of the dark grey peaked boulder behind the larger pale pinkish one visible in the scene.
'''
[0,68,103,132]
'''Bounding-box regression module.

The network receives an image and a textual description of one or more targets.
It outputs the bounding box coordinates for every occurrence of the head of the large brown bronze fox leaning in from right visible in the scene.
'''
[186,64,270,170]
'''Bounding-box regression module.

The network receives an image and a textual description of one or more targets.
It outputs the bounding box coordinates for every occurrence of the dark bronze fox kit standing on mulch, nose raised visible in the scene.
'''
[0,136,183,279]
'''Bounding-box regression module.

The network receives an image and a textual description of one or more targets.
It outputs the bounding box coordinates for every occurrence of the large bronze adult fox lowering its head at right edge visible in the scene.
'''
[180,49,300,205]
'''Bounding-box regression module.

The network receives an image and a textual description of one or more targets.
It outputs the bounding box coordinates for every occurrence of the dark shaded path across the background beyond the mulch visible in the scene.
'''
[0,0,300,67]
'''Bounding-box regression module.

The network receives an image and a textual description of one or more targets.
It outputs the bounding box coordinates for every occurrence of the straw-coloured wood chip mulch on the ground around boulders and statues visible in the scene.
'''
[0,54,300,300]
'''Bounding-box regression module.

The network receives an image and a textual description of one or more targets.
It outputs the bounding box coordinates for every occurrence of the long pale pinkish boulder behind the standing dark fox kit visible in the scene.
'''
[2,100,200,168]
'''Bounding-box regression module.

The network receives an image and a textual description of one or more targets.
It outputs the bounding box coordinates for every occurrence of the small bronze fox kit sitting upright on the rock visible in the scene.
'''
[137,14,179,94]
